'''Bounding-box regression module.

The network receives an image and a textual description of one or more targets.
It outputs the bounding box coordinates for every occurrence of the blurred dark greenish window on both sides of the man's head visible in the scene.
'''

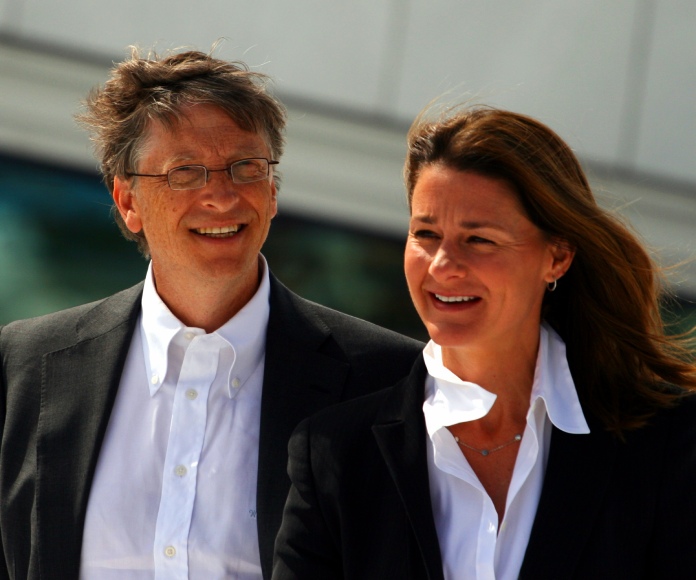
[0,156,425,338]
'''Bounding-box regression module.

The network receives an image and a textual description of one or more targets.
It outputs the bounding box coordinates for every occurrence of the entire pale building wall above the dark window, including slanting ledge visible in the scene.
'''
[0,0,696,295]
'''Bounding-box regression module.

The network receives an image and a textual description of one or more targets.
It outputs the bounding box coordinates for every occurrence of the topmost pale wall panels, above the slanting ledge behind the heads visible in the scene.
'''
[5,0,696,183]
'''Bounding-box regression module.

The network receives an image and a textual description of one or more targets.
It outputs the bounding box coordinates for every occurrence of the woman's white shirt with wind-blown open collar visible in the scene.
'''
[423,324,590,580]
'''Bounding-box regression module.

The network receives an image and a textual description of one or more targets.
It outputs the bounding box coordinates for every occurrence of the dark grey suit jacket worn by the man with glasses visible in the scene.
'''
[0,276,423,579]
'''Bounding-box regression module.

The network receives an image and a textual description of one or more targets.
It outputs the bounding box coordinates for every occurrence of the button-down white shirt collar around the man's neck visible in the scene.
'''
[140,255,270,398]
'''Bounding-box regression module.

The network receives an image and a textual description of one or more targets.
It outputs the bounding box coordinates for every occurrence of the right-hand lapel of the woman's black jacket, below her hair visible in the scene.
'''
[520,415,618,578]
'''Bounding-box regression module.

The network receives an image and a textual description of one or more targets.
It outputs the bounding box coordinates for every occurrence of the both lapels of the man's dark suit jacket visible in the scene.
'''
[37,274,358,578]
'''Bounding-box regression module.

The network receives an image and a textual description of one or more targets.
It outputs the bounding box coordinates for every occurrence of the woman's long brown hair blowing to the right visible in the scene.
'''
[404,107,696,434]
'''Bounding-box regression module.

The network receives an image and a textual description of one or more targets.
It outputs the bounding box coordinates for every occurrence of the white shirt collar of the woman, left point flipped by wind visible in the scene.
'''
[423,323,590,436]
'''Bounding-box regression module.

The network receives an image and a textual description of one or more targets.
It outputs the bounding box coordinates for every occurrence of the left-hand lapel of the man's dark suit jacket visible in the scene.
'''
[36,284,142,578]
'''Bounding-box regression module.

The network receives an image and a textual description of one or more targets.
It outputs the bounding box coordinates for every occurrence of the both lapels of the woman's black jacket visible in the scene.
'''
[373,357,618,579]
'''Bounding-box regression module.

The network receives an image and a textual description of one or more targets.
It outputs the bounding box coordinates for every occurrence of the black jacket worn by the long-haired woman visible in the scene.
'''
[273,357,696,580]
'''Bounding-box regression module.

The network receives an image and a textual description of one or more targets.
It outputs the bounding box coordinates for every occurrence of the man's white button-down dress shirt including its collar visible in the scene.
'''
[80,261,270,580]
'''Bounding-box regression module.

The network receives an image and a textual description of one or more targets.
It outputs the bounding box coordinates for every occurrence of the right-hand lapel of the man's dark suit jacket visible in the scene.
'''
[257,275,349,578]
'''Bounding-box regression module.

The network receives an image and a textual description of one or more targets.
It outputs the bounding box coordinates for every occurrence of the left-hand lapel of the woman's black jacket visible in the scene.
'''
[372,356,444,580]
